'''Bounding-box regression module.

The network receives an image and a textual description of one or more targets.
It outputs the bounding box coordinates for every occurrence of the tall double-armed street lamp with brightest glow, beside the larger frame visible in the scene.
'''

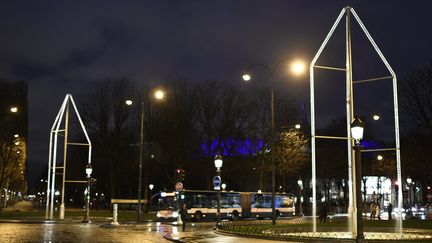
[242,58,305,225]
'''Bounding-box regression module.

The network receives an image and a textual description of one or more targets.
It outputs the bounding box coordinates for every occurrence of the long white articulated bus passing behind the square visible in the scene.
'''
[154,190,295,221]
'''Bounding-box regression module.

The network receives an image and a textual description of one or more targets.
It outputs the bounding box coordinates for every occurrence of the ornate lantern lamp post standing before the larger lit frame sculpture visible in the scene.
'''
[351,116,364,242]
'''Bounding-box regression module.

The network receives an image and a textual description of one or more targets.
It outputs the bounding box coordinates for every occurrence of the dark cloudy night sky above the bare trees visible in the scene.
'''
[0,0,432,186]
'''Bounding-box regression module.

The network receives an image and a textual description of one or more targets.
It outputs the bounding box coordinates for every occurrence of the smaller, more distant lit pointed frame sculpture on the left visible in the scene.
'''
[45,94,92,219]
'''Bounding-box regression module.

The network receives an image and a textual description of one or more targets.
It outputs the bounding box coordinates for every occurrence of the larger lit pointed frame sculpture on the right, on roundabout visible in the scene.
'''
[309,6,402,236]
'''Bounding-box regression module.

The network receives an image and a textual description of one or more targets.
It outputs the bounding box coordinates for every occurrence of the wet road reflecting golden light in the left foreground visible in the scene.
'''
[0,223,278,243]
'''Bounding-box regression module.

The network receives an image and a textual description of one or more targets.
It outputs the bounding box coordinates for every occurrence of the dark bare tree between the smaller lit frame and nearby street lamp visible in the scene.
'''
[80,78,139,197]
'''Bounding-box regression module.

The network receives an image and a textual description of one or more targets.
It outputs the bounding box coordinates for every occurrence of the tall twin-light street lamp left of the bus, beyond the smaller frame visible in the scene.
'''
[125,89,165,223]
